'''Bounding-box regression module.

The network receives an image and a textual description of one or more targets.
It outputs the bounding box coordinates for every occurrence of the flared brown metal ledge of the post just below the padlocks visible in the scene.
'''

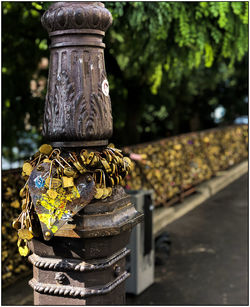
[56,186,143,238]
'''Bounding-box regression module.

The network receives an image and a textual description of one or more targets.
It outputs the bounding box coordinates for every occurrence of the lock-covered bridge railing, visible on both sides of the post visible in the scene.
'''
[2,125,248,287]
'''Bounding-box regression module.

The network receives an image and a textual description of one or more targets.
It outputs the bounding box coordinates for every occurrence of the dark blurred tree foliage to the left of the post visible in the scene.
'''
[2,2,49,164]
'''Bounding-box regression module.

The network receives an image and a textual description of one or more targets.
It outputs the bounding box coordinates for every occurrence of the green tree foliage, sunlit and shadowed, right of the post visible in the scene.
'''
[106,2,248,143]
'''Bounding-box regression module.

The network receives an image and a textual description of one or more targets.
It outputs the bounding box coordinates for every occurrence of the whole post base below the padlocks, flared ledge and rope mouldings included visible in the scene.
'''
[29,187,143,305]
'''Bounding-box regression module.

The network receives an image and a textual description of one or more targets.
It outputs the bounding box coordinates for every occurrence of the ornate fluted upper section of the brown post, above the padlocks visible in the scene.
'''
[42,2,113,142]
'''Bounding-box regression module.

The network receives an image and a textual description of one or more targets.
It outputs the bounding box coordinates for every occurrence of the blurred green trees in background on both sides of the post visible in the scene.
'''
[1,1,248,168]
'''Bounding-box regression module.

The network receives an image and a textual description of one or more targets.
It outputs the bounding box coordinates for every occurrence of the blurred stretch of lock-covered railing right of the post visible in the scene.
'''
[124,125,248,206]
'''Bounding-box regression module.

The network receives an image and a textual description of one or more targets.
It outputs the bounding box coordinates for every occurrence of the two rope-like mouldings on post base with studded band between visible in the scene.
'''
[29,248,129,304]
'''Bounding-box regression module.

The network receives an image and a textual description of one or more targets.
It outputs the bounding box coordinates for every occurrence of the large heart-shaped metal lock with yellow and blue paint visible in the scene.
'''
[28,163,96,240]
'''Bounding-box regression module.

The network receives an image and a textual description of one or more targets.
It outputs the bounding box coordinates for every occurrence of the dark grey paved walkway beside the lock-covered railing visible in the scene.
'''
[2,175,249,305]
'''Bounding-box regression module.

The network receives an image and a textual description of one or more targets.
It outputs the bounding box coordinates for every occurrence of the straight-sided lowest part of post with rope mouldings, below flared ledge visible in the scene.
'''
[29,231,130,305]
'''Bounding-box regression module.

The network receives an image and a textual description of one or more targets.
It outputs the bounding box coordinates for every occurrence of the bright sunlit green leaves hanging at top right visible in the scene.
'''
[107,1,248,94]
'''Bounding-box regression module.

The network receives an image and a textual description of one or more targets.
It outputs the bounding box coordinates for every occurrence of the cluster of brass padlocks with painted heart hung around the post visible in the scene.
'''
[12,144,131,256]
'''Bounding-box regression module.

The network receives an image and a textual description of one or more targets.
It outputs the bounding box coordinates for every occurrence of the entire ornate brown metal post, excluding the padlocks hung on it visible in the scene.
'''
[29,2,142,305]
